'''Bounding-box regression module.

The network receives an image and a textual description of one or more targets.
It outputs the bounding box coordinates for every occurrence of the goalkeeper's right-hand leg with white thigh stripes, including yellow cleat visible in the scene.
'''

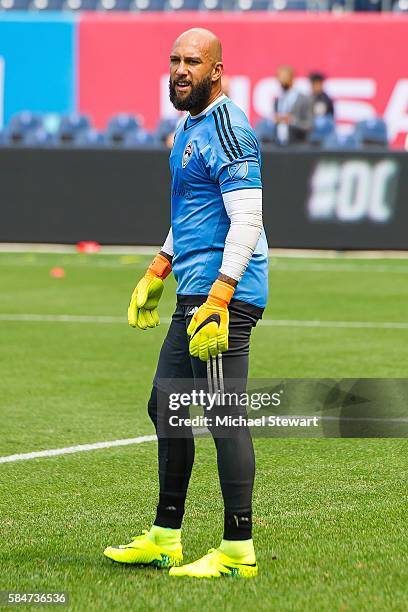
[171,303,257,577]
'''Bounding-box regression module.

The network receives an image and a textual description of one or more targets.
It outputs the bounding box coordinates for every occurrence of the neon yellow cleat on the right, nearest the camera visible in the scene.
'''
[169,548,258,578]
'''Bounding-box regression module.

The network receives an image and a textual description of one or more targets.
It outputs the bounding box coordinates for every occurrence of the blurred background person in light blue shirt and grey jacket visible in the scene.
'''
[274,66,313,145]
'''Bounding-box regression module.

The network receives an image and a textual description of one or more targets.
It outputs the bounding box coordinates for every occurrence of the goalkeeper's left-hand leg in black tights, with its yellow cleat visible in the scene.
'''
[104,307,194,567]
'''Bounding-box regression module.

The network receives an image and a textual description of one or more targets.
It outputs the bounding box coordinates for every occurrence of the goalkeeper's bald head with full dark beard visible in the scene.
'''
[170,28,223,115]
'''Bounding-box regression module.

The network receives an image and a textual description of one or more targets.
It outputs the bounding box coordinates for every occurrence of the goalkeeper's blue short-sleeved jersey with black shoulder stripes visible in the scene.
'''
[170,96,268,308]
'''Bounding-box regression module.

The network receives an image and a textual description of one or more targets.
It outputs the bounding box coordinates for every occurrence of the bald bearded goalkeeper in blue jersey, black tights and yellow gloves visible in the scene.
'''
[105,28,268,578]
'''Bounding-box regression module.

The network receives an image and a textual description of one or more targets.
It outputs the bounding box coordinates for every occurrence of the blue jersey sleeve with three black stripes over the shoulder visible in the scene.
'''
[203,109,262,193]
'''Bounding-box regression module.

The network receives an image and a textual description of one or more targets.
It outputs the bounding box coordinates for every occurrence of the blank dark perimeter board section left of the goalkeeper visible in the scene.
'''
[0,149,170,244]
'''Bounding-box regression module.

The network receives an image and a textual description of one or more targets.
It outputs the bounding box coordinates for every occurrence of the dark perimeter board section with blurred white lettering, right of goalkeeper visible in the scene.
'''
[263,152,408,250]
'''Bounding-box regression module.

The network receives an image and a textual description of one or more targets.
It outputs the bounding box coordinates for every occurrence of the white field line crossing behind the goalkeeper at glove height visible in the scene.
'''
[0,314,408,329]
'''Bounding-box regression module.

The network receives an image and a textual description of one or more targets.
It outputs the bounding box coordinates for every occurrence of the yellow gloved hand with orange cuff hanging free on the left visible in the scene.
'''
[128,254,171,329]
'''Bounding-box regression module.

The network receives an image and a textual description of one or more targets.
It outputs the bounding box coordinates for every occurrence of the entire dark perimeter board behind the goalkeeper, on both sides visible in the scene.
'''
[0,148,408,249]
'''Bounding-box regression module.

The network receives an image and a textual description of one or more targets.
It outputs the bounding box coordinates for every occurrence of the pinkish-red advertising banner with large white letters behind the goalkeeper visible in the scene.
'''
[79,12,408,146]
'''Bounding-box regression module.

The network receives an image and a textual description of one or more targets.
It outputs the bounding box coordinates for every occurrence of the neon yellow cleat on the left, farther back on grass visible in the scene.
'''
[103,531,183,568]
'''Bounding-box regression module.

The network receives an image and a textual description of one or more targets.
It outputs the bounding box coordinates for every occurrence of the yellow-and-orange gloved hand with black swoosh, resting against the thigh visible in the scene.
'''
[187,279,235,361]
